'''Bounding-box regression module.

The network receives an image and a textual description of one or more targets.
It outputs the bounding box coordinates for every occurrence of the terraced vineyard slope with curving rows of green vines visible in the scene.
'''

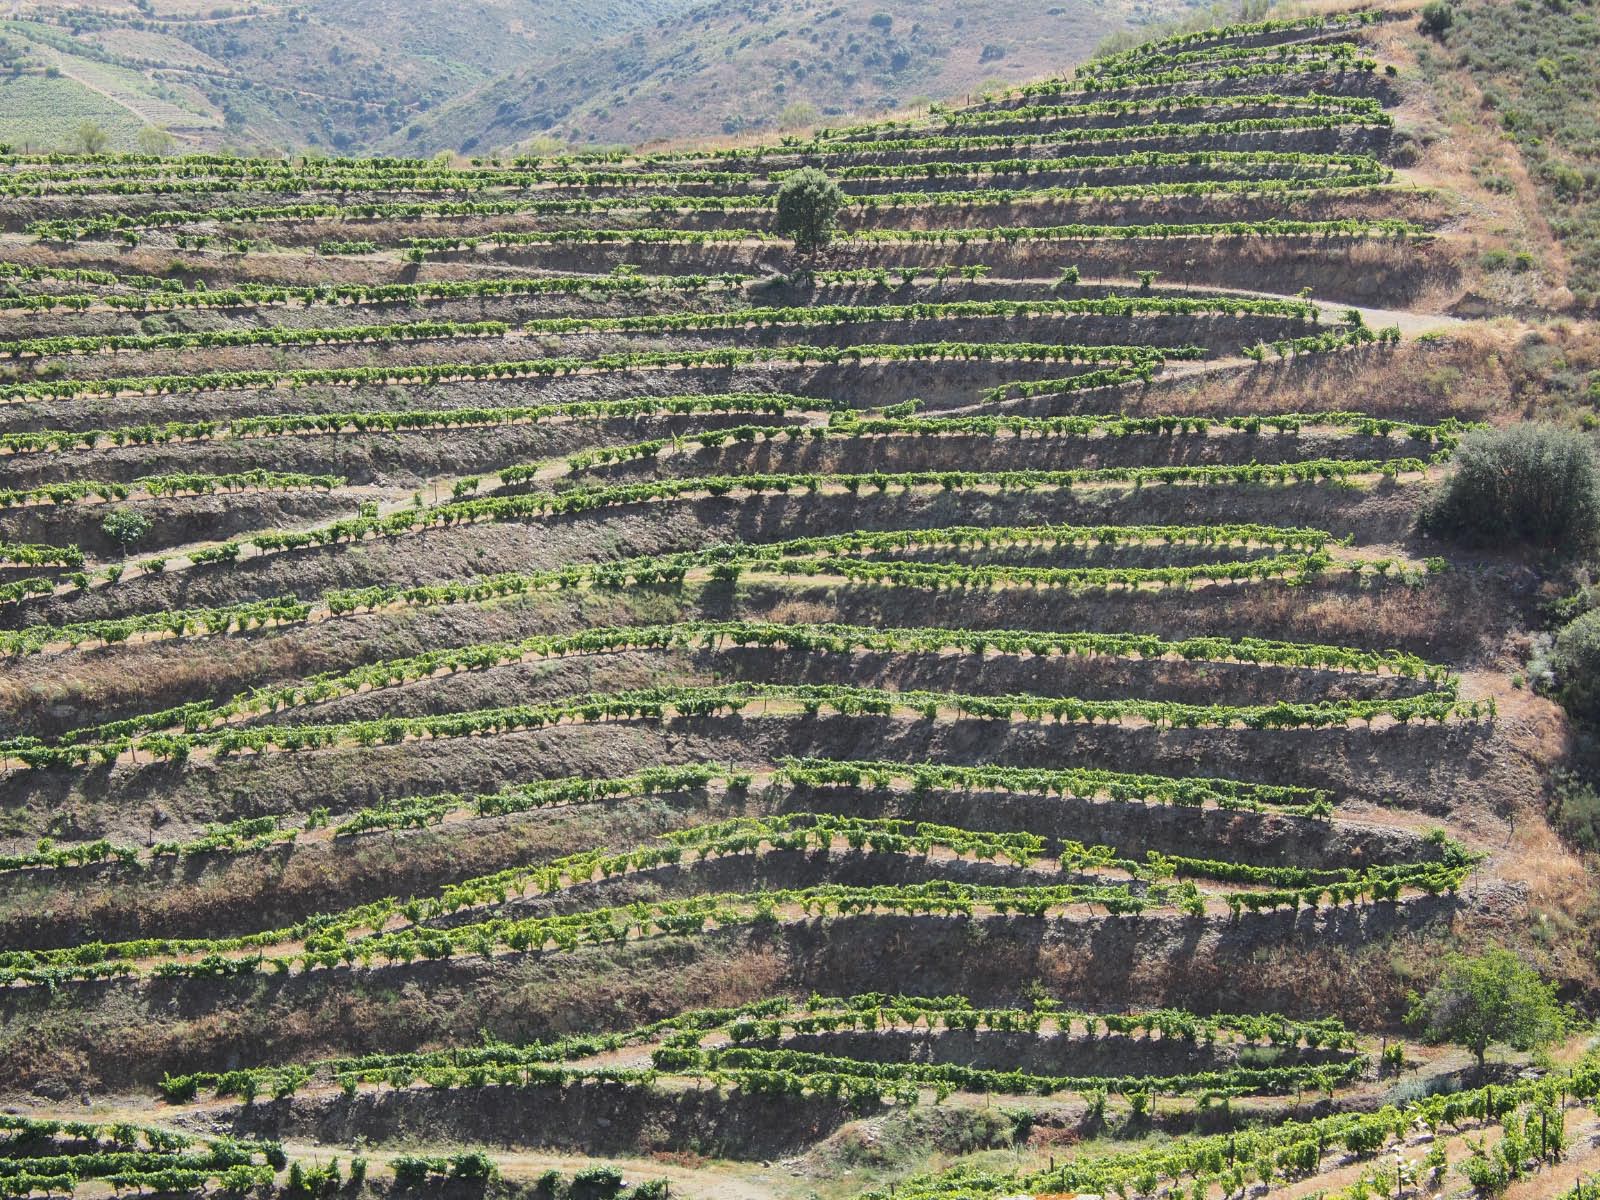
[0,11,1600,1200]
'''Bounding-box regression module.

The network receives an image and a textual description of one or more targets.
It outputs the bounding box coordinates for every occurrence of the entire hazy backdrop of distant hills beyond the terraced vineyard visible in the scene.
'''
[0,0,1192,154]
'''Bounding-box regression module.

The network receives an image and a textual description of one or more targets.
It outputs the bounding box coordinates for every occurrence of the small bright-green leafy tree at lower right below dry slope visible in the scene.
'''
[1406,947,1565,1070]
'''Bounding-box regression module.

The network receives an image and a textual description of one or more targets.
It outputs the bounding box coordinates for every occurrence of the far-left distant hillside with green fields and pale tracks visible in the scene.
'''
[0,0,700,154]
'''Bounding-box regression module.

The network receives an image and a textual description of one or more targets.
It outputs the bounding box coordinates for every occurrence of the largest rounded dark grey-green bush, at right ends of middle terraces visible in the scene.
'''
[1422,422,1600,555]
